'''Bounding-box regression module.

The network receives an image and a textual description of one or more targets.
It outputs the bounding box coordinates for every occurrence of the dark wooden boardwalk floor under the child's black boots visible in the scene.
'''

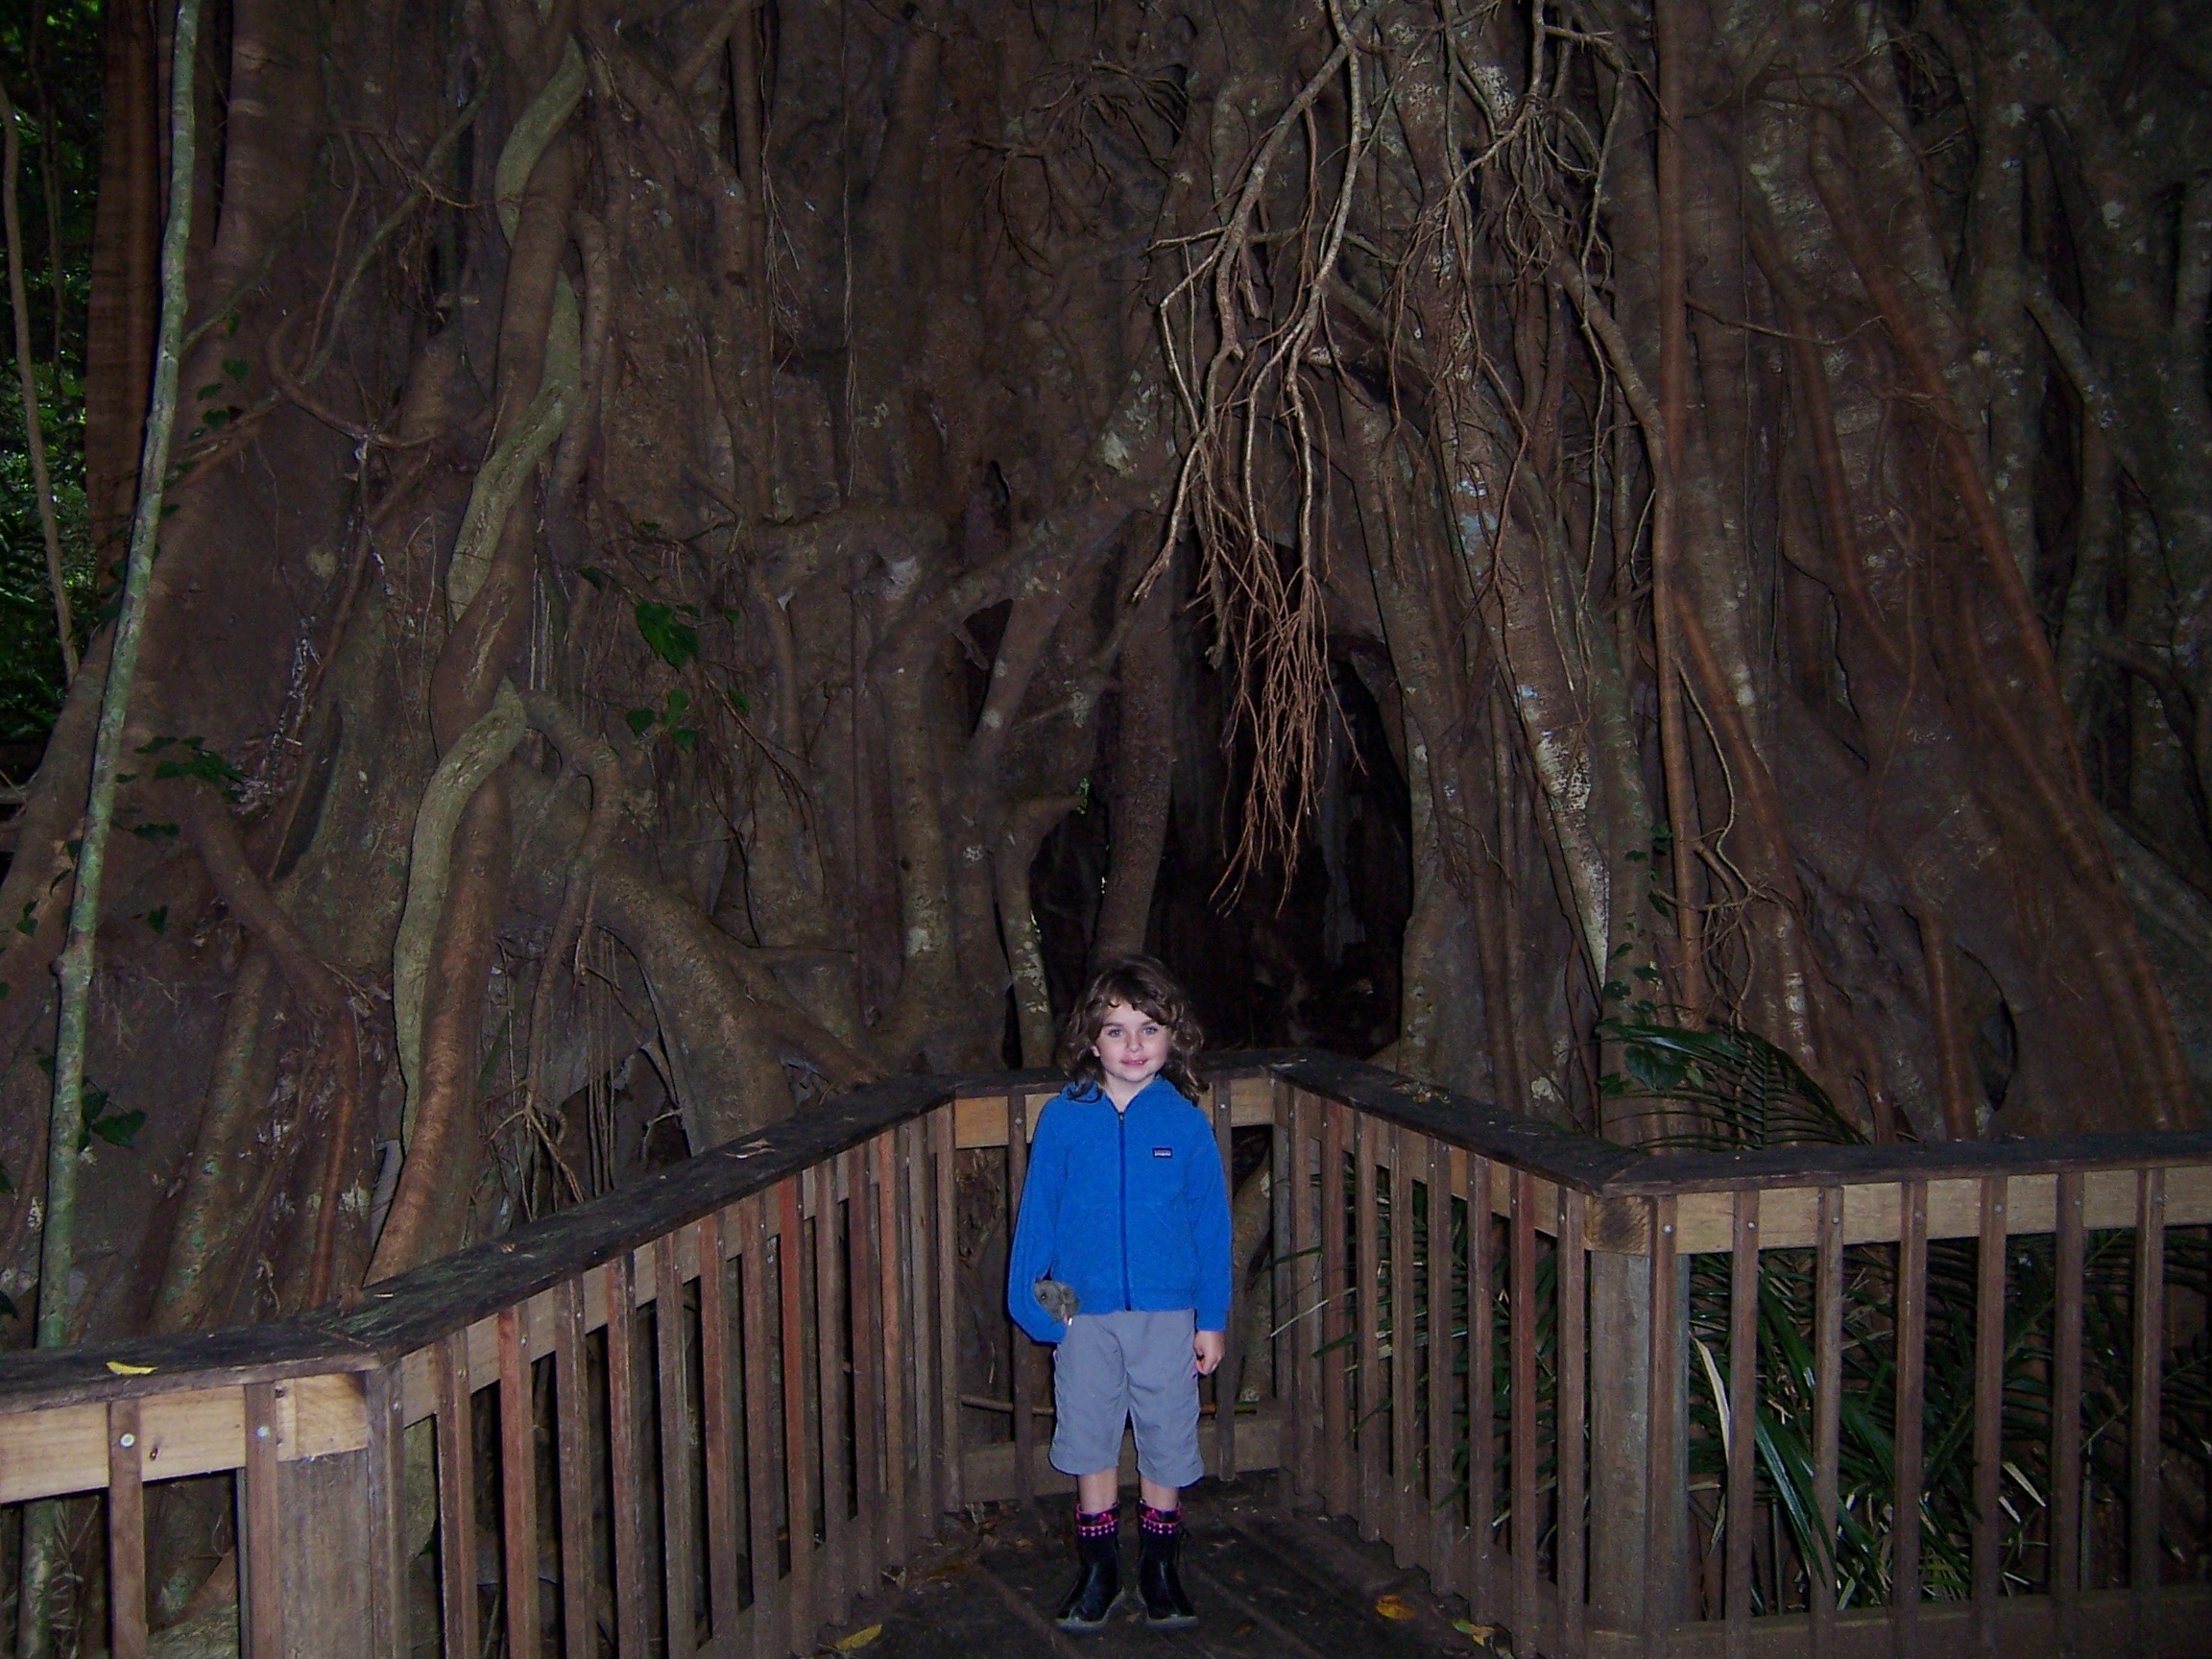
[825,1476,1511,1659]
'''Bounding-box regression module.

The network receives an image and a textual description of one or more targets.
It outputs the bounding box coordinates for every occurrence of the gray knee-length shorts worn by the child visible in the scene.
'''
[1053,1308,1206,1486]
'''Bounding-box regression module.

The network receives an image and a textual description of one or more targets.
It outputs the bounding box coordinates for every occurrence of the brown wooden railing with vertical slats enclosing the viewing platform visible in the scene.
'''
[0,1053,2212,1659]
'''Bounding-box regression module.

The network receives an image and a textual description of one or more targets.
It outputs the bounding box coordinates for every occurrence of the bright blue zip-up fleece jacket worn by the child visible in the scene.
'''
[1006,1077,1230,1343]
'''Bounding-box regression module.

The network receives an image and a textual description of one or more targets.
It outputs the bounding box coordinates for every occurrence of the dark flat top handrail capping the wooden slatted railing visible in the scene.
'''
[0,1048,2212,1411]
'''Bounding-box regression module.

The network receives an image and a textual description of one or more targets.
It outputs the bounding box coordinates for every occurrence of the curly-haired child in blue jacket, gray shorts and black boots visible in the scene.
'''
[1006,958,1230,1632]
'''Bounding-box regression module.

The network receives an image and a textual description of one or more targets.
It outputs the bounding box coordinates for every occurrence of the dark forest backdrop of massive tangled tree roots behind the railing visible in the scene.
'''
[0,0,2212,1338]
